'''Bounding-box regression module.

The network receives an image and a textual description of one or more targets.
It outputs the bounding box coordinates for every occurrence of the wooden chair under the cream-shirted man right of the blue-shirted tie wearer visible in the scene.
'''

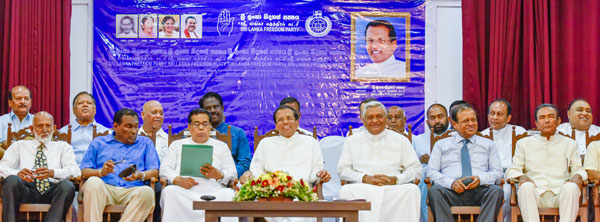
[508,126,588,221]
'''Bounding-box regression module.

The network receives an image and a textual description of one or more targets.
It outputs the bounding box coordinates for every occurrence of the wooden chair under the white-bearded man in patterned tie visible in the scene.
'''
[0,123,78,222]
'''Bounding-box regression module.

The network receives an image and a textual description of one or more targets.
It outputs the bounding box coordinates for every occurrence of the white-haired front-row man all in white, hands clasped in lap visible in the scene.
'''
[338,101,421,222]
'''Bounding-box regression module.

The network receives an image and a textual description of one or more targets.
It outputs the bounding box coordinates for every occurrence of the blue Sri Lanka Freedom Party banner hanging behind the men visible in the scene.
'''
[93,0,425,141]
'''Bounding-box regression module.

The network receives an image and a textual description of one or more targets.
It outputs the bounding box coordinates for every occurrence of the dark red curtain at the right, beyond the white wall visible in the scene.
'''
[462,0,600,129]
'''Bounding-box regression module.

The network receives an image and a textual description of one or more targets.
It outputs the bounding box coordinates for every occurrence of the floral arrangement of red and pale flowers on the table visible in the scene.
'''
[233,171,317,201]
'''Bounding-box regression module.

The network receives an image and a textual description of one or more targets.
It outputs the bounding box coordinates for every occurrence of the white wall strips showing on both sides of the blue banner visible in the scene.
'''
[70,0,462,125]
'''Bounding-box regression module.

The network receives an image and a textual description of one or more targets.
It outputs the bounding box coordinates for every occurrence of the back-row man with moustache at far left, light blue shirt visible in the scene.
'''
[0,86,33,142]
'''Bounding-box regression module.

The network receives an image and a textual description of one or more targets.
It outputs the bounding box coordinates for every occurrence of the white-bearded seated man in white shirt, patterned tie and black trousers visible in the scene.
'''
[0,111,81,221]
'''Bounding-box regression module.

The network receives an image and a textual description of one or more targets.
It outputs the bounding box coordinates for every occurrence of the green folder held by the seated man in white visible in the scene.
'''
[179,144,213,178]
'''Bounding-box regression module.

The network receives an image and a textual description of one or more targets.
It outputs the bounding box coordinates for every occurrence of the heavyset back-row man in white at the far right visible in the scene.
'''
[556,99,600,156]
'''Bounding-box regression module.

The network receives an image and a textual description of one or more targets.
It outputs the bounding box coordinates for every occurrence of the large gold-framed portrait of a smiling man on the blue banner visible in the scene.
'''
[350,12,410,82]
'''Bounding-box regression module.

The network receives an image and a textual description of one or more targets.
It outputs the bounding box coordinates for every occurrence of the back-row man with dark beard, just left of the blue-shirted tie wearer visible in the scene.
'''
[412,103,448,222]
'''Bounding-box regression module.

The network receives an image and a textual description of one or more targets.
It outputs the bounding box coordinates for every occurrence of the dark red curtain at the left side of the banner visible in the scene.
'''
[0,0,71,126]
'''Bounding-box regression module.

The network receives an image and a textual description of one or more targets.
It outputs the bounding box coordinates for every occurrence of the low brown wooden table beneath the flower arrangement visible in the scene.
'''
[193,201,371,222]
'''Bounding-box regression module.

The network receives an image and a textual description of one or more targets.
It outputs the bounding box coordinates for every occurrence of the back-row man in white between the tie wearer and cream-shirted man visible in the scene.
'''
[481,99,527,222]
